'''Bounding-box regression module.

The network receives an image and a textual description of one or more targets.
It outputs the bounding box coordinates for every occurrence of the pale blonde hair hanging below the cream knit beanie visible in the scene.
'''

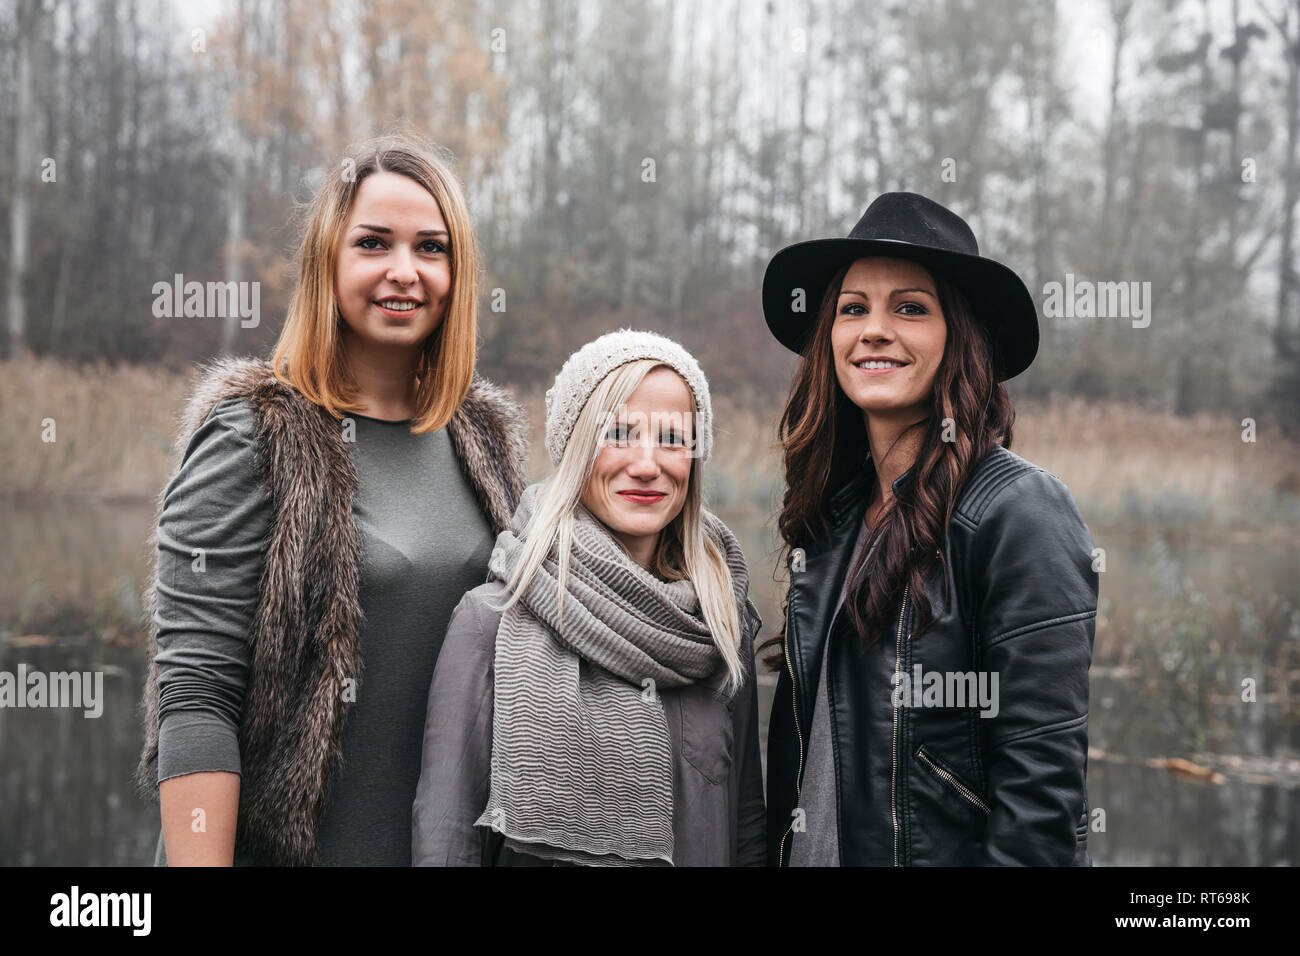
[497,359,745,693]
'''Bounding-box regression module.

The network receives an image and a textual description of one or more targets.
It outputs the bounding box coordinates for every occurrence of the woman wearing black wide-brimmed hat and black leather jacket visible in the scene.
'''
[763,193,1097,866]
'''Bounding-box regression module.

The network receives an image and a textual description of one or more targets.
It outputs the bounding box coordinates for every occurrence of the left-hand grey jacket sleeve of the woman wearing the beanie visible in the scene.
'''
[411,583,506,866]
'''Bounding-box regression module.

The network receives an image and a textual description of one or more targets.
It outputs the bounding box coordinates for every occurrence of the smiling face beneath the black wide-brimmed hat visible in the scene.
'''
[831,256,948,423]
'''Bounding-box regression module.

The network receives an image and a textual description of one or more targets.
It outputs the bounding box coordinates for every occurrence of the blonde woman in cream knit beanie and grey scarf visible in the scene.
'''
[412,329,764,866]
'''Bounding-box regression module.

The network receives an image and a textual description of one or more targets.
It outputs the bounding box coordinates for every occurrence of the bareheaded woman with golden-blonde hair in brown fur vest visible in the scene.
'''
[138,137,525,866]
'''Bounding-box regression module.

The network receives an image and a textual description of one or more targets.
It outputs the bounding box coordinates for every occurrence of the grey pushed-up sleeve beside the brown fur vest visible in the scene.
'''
[155,399,272,782]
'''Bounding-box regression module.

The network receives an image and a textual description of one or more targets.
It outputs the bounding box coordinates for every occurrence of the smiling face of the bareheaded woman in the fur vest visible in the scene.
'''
[334,172,451,350]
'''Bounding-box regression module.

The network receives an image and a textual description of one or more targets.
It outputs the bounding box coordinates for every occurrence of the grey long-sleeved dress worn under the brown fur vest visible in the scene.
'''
[155,399,494,866]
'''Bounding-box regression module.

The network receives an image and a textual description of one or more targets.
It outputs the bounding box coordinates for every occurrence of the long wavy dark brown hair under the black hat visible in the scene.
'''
[763,263,1015,669]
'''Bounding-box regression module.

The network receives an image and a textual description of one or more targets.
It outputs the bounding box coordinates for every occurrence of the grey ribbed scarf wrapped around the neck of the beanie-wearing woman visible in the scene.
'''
[476,484,749,866]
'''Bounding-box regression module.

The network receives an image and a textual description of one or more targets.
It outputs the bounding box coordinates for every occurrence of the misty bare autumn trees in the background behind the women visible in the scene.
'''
[0,0,1300,416]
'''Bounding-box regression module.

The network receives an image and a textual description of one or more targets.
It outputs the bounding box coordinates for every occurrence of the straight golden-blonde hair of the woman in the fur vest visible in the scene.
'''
[272,133,478,434]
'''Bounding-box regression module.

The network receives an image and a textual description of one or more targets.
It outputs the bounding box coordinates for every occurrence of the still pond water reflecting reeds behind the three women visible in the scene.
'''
[0,503,1300,866]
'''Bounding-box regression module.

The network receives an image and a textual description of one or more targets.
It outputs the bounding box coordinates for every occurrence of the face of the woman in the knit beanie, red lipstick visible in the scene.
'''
[581,367,696,567]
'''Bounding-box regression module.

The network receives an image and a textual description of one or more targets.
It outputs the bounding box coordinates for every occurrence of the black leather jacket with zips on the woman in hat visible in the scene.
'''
[767,447,1097,866]
